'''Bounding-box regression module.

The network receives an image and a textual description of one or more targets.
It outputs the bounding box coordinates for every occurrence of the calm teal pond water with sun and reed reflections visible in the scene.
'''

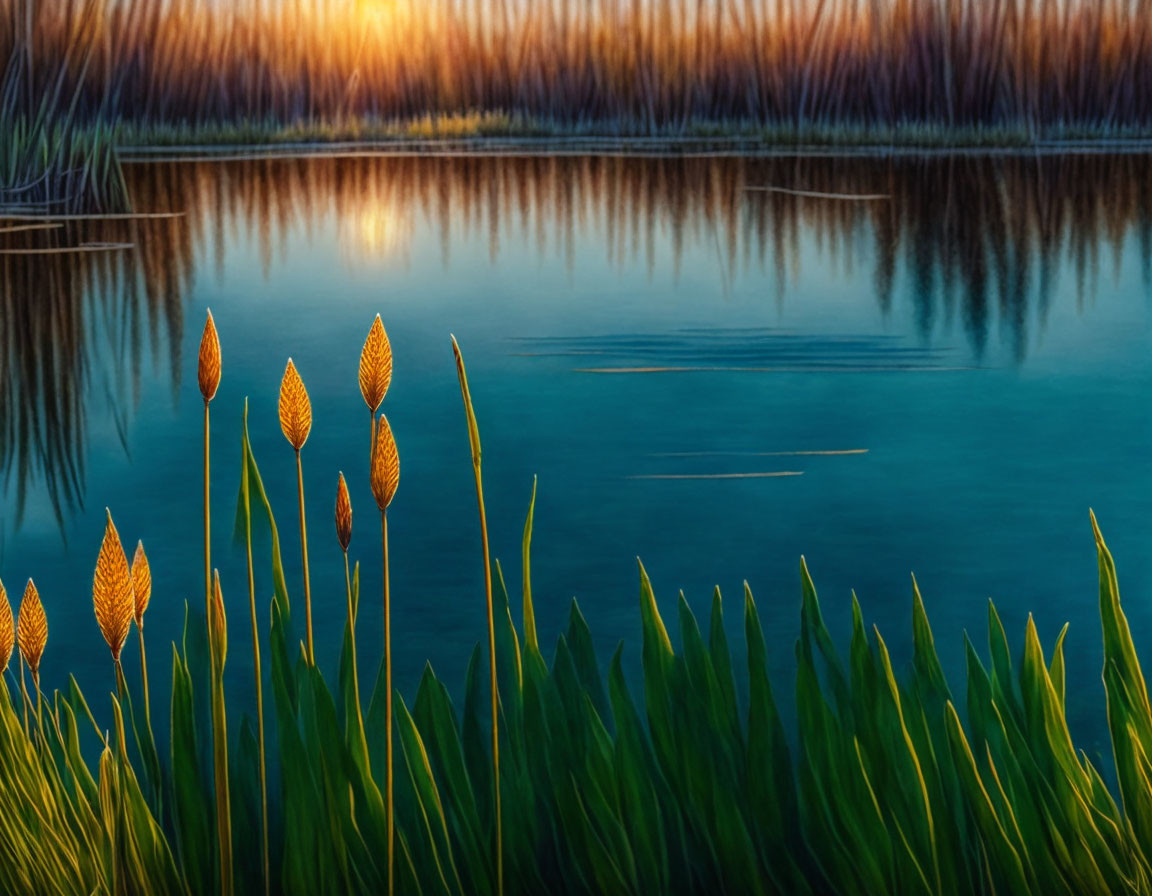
[0,155,1152,749]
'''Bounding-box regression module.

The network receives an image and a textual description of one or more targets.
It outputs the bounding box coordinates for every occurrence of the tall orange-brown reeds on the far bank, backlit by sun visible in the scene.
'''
[0,0,1152,139]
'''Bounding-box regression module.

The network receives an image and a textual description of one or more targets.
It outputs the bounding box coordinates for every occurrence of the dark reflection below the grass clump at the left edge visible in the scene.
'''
[0,210,191,525]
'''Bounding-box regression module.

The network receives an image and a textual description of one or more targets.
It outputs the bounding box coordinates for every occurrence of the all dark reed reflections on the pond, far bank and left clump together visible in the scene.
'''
[0,154,1152,523]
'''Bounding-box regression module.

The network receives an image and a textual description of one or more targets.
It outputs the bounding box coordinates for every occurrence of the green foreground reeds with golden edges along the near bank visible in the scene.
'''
[0,315,1152,896]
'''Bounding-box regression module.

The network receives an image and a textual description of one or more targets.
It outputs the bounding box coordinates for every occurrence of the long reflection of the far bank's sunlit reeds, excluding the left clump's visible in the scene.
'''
[127,154,1152,359]
